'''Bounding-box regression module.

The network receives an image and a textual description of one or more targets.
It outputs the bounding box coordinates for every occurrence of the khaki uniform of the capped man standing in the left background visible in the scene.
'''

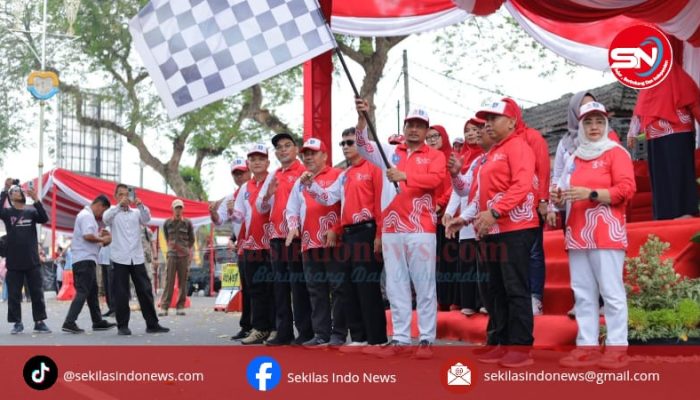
[160,218,195,310]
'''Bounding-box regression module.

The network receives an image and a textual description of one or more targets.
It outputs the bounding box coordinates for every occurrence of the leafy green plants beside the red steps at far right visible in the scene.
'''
[625,235,700,344]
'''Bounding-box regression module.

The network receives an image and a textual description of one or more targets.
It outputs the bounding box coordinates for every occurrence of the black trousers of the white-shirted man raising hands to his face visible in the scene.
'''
[111,262,158,328]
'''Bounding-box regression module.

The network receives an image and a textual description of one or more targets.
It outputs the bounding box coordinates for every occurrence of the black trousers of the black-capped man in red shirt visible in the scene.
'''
[270,239,314,341]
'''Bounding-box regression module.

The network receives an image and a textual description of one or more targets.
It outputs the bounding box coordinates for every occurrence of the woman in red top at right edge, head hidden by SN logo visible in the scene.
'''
[627,65,700,220]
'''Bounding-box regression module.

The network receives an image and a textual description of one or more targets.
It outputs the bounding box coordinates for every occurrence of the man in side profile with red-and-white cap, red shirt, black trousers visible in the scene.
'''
[474,101,539,368]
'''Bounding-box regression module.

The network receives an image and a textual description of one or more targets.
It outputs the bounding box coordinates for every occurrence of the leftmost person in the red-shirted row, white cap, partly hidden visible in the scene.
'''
[209,158,253,340]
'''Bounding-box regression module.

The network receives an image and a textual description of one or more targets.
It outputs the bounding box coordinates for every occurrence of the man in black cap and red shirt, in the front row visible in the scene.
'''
[255,133,314,346]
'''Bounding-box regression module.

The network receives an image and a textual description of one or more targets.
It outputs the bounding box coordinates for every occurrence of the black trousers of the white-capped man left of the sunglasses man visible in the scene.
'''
[302,248,350,340]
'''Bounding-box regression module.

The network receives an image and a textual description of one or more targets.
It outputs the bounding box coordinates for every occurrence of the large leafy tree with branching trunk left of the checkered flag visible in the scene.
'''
[0,0,300,199]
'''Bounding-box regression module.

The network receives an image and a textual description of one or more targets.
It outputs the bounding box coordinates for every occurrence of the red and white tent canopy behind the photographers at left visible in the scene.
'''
[25,168,211,232]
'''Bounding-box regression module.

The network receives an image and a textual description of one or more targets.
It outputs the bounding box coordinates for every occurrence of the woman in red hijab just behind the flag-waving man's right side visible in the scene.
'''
[425,125,459,311]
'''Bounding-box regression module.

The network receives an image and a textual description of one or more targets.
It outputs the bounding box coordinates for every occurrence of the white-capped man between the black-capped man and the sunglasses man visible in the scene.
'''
[287,138,348,347]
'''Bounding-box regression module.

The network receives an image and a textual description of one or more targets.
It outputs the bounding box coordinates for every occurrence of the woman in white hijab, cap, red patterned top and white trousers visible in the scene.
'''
[550,101,636,368]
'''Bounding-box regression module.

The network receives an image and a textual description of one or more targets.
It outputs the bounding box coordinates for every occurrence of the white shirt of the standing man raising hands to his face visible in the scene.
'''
[102,205,151,265]
